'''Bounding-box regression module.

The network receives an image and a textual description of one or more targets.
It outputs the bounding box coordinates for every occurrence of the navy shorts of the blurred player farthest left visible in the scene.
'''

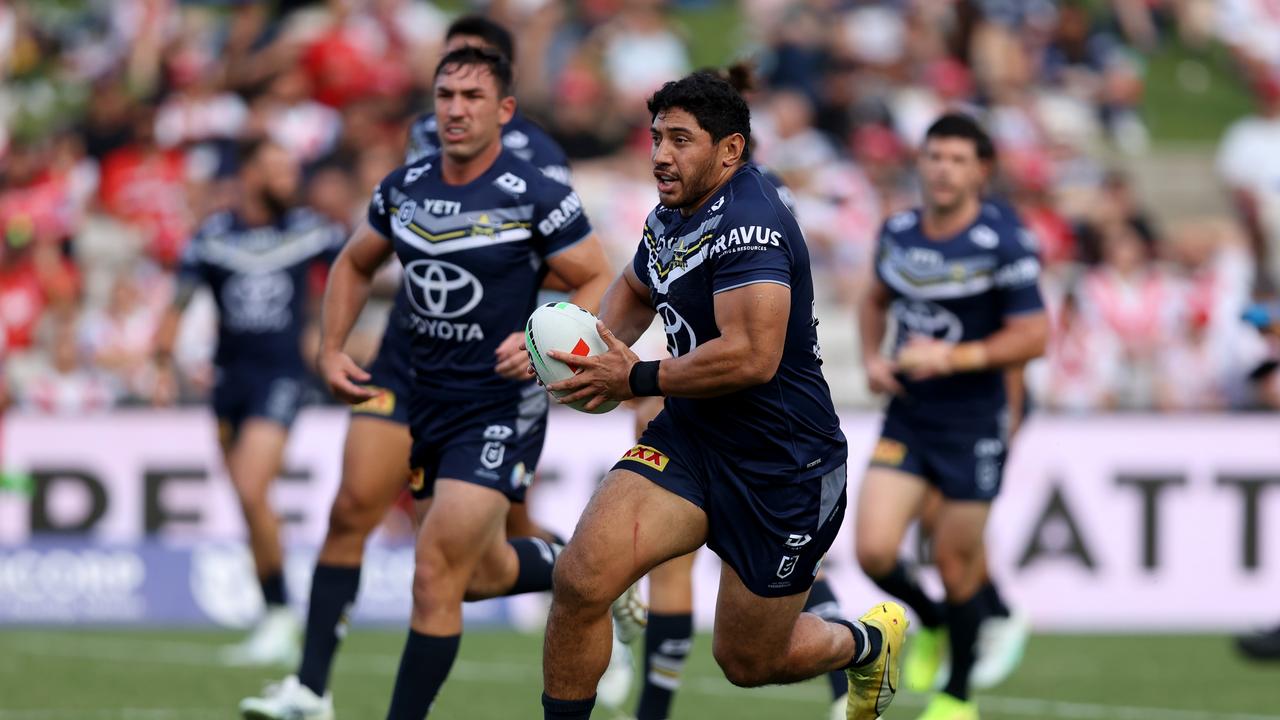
[212,368,307,439]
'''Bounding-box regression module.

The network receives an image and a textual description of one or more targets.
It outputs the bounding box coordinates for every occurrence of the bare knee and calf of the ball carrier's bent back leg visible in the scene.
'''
[712,565,856,688]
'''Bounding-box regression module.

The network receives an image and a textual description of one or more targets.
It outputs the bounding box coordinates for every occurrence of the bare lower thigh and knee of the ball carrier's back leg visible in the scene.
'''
[712,562,809,665]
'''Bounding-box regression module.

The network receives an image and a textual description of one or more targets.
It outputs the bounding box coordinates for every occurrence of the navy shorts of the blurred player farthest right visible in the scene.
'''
[872,413,1009,502]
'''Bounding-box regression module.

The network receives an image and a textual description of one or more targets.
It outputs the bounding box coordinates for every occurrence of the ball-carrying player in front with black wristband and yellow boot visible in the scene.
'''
[543,73,906,720]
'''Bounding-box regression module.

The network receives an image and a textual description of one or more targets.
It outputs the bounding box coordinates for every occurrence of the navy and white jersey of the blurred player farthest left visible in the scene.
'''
[178,208,347,372]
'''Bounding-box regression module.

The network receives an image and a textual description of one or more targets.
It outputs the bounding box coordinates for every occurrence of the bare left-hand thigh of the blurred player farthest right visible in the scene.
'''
[855,465,929,568]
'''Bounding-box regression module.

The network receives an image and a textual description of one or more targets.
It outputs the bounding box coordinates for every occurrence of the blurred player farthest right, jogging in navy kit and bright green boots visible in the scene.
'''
[856,114,1048,720]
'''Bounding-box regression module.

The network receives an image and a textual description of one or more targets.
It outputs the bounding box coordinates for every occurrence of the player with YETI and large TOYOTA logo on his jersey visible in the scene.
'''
[320,47,608,720]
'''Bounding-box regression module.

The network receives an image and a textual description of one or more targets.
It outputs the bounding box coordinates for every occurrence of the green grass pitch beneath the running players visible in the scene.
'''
[0,630,1280,720]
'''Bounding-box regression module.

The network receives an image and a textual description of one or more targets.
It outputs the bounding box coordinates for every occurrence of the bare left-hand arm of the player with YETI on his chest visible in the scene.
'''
[316,223,392,404]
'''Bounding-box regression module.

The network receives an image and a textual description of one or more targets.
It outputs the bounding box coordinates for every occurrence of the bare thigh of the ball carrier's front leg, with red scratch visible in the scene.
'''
[557,469,707,600]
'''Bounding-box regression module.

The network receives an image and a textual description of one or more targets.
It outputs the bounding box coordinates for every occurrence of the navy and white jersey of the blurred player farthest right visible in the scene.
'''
[876,201,1044,420]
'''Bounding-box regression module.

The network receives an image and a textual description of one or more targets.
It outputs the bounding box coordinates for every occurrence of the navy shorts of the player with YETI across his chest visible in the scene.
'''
[410,384,549,502]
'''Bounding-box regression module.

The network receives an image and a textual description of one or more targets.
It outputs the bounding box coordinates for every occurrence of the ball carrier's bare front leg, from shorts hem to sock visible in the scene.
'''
[543,470,707,701]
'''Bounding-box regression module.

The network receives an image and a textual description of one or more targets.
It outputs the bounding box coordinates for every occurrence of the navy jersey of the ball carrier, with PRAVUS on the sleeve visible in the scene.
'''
[634,165,847,478]
